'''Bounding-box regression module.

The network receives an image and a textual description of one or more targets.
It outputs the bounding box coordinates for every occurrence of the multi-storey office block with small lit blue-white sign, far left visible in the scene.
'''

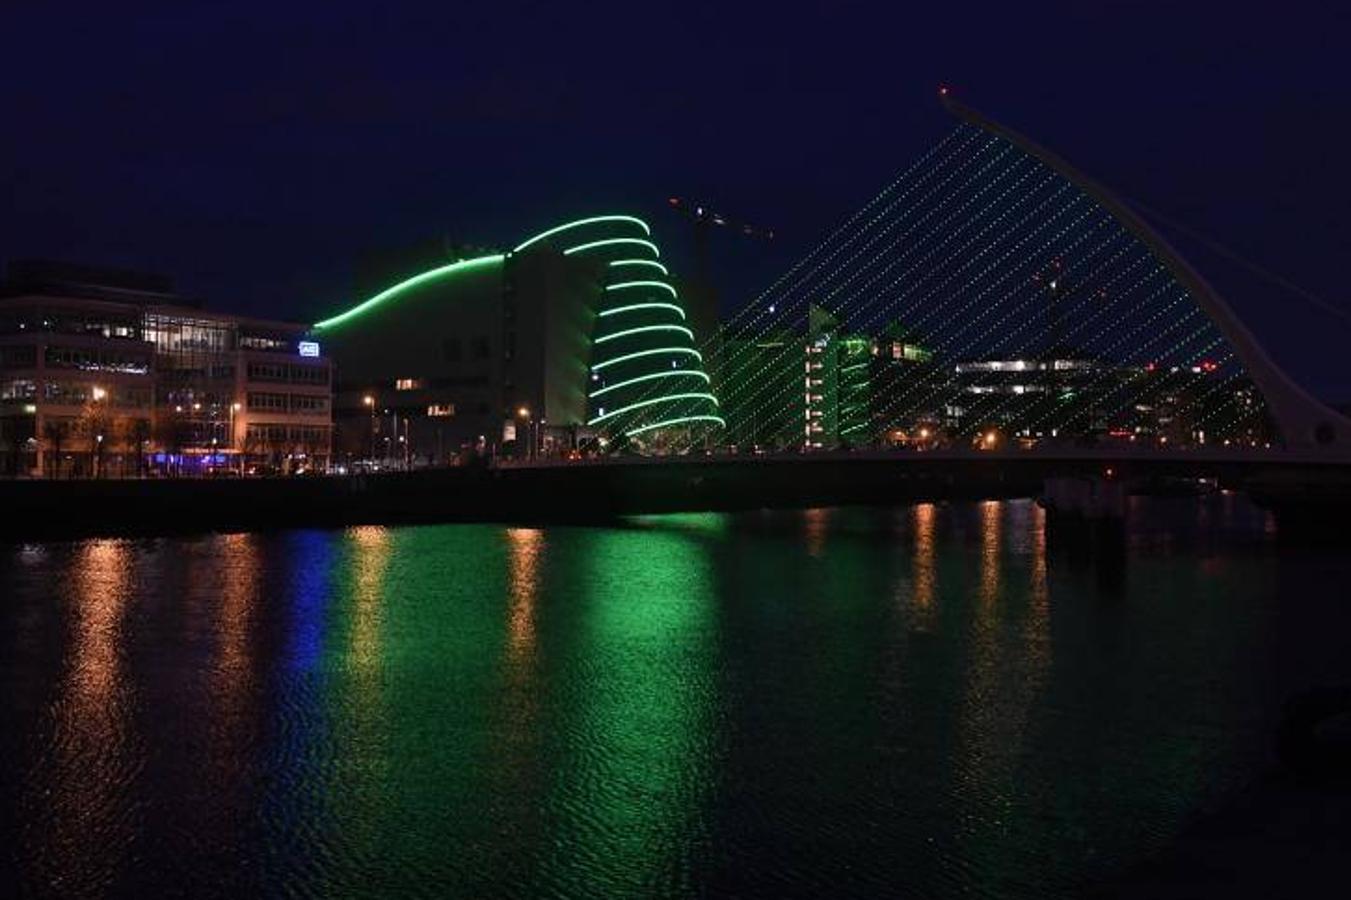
[0,261,331,476]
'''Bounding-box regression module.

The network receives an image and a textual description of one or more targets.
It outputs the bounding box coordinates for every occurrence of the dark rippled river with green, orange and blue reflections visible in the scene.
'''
[0,495,1351,897]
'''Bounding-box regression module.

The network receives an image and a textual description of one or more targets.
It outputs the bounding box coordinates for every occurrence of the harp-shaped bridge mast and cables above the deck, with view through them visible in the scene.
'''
[634,92,1351,458]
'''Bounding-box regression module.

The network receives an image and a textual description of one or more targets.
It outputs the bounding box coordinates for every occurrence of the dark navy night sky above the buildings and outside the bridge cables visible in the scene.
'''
[0,0,1351,401]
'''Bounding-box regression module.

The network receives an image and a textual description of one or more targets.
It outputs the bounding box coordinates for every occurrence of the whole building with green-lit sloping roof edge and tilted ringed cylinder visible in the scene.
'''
[313,215,724,465]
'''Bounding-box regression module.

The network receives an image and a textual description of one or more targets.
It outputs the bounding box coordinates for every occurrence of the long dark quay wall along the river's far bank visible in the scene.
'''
[0,461,1042,541]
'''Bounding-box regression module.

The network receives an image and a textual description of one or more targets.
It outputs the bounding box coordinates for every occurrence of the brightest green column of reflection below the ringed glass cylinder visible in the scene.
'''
[547,516,719,896]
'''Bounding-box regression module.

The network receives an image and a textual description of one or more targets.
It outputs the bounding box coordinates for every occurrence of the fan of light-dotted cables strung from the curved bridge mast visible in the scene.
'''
[680,124,1269,451]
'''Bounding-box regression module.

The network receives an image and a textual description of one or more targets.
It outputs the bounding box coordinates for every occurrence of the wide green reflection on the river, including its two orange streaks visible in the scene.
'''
[311,516,723,895]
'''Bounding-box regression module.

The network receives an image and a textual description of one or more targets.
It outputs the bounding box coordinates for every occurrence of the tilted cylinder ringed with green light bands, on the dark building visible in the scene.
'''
[512,215,725,449]
